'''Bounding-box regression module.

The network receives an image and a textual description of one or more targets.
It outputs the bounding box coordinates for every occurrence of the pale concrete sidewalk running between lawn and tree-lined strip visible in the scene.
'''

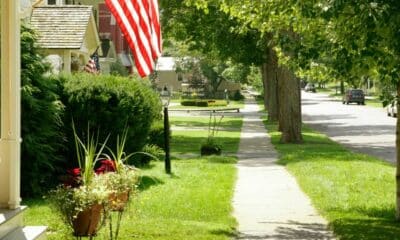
[233,96,334,239]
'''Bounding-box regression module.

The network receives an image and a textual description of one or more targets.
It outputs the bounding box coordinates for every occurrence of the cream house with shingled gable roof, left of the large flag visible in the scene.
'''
[31,5,101,72]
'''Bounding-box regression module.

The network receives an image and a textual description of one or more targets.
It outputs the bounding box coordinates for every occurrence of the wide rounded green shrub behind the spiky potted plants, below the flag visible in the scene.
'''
[63,74,161,163]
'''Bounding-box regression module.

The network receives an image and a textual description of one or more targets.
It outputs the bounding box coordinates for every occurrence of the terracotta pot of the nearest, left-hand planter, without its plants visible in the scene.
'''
[72,204,103,237]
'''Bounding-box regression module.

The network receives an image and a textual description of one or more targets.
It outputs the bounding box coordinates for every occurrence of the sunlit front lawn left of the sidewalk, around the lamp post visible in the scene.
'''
[24,113,241,240]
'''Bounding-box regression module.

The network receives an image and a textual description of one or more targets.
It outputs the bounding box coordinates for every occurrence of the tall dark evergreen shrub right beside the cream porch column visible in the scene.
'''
[21,26,64,197]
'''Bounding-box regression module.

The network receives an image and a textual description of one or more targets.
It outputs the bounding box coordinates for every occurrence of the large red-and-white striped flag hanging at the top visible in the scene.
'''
[105,0,161,77]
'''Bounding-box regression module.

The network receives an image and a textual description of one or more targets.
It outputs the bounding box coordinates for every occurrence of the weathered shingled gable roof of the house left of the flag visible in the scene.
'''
[31,5,92,49]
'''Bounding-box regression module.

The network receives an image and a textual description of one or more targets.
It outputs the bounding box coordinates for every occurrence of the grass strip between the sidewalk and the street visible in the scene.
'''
[266,123,400,240]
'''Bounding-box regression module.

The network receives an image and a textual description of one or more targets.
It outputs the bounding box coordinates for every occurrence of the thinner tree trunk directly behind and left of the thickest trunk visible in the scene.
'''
[265,47,280,122]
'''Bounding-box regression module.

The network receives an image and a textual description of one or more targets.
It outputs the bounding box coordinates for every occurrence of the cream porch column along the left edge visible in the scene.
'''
[0,0,21,209]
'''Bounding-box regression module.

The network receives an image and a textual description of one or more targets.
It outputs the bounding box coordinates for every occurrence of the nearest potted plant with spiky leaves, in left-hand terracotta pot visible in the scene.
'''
[48,127,110,237]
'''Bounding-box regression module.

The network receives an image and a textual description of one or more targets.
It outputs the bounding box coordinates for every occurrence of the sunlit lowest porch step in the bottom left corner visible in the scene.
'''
[0,226,47,240]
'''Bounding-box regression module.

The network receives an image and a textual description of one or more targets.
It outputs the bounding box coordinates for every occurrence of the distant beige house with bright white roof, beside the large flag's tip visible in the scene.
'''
[156,57,182,91]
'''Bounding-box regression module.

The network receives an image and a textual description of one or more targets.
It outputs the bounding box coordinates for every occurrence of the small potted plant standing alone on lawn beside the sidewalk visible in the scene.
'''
[200,112,224,156]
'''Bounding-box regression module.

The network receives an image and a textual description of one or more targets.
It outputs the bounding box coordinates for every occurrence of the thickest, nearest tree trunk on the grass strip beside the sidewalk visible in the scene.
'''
[278,66,303,143]
